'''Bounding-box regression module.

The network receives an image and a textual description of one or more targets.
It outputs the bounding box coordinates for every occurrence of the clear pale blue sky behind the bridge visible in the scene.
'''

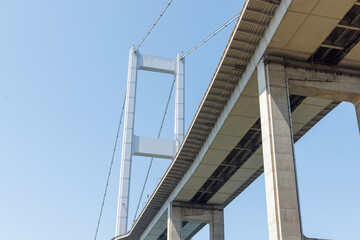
[0,0,360,240]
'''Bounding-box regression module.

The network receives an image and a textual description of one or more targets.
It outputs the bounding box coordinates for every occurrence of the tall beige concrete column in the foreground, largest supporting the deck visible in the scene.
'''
[257,61,302,240]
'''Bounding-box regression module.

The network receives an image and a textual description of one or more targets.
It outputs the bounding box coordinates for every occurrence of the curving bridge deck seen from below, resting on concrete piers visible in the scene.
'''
[114,0,360,240]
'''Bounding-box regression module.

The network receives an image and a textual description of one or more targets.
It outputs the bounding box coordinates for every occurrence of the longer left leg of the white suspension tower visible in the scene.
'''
[115,47,138,236]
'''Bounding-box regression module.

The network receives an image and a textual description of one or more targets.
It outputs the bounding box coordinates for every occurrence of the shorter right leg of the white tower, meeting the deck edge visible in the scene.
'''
[174,53,185,152]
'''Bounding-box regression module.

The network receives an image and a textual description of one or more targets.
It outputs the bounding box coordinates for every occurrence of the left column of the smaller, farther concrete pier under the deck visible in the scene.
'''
[167,203,182,240]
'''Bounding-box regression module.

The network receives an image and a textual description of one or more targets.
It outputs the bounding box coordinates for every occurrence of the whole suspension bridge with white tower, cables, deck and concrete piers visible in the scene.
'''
[95,0,360,240]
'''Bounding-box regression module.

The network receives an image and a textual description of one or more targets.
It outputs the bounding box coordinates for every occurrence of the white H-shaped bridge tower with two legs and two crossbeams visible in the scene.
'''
[115,47,184,235]
